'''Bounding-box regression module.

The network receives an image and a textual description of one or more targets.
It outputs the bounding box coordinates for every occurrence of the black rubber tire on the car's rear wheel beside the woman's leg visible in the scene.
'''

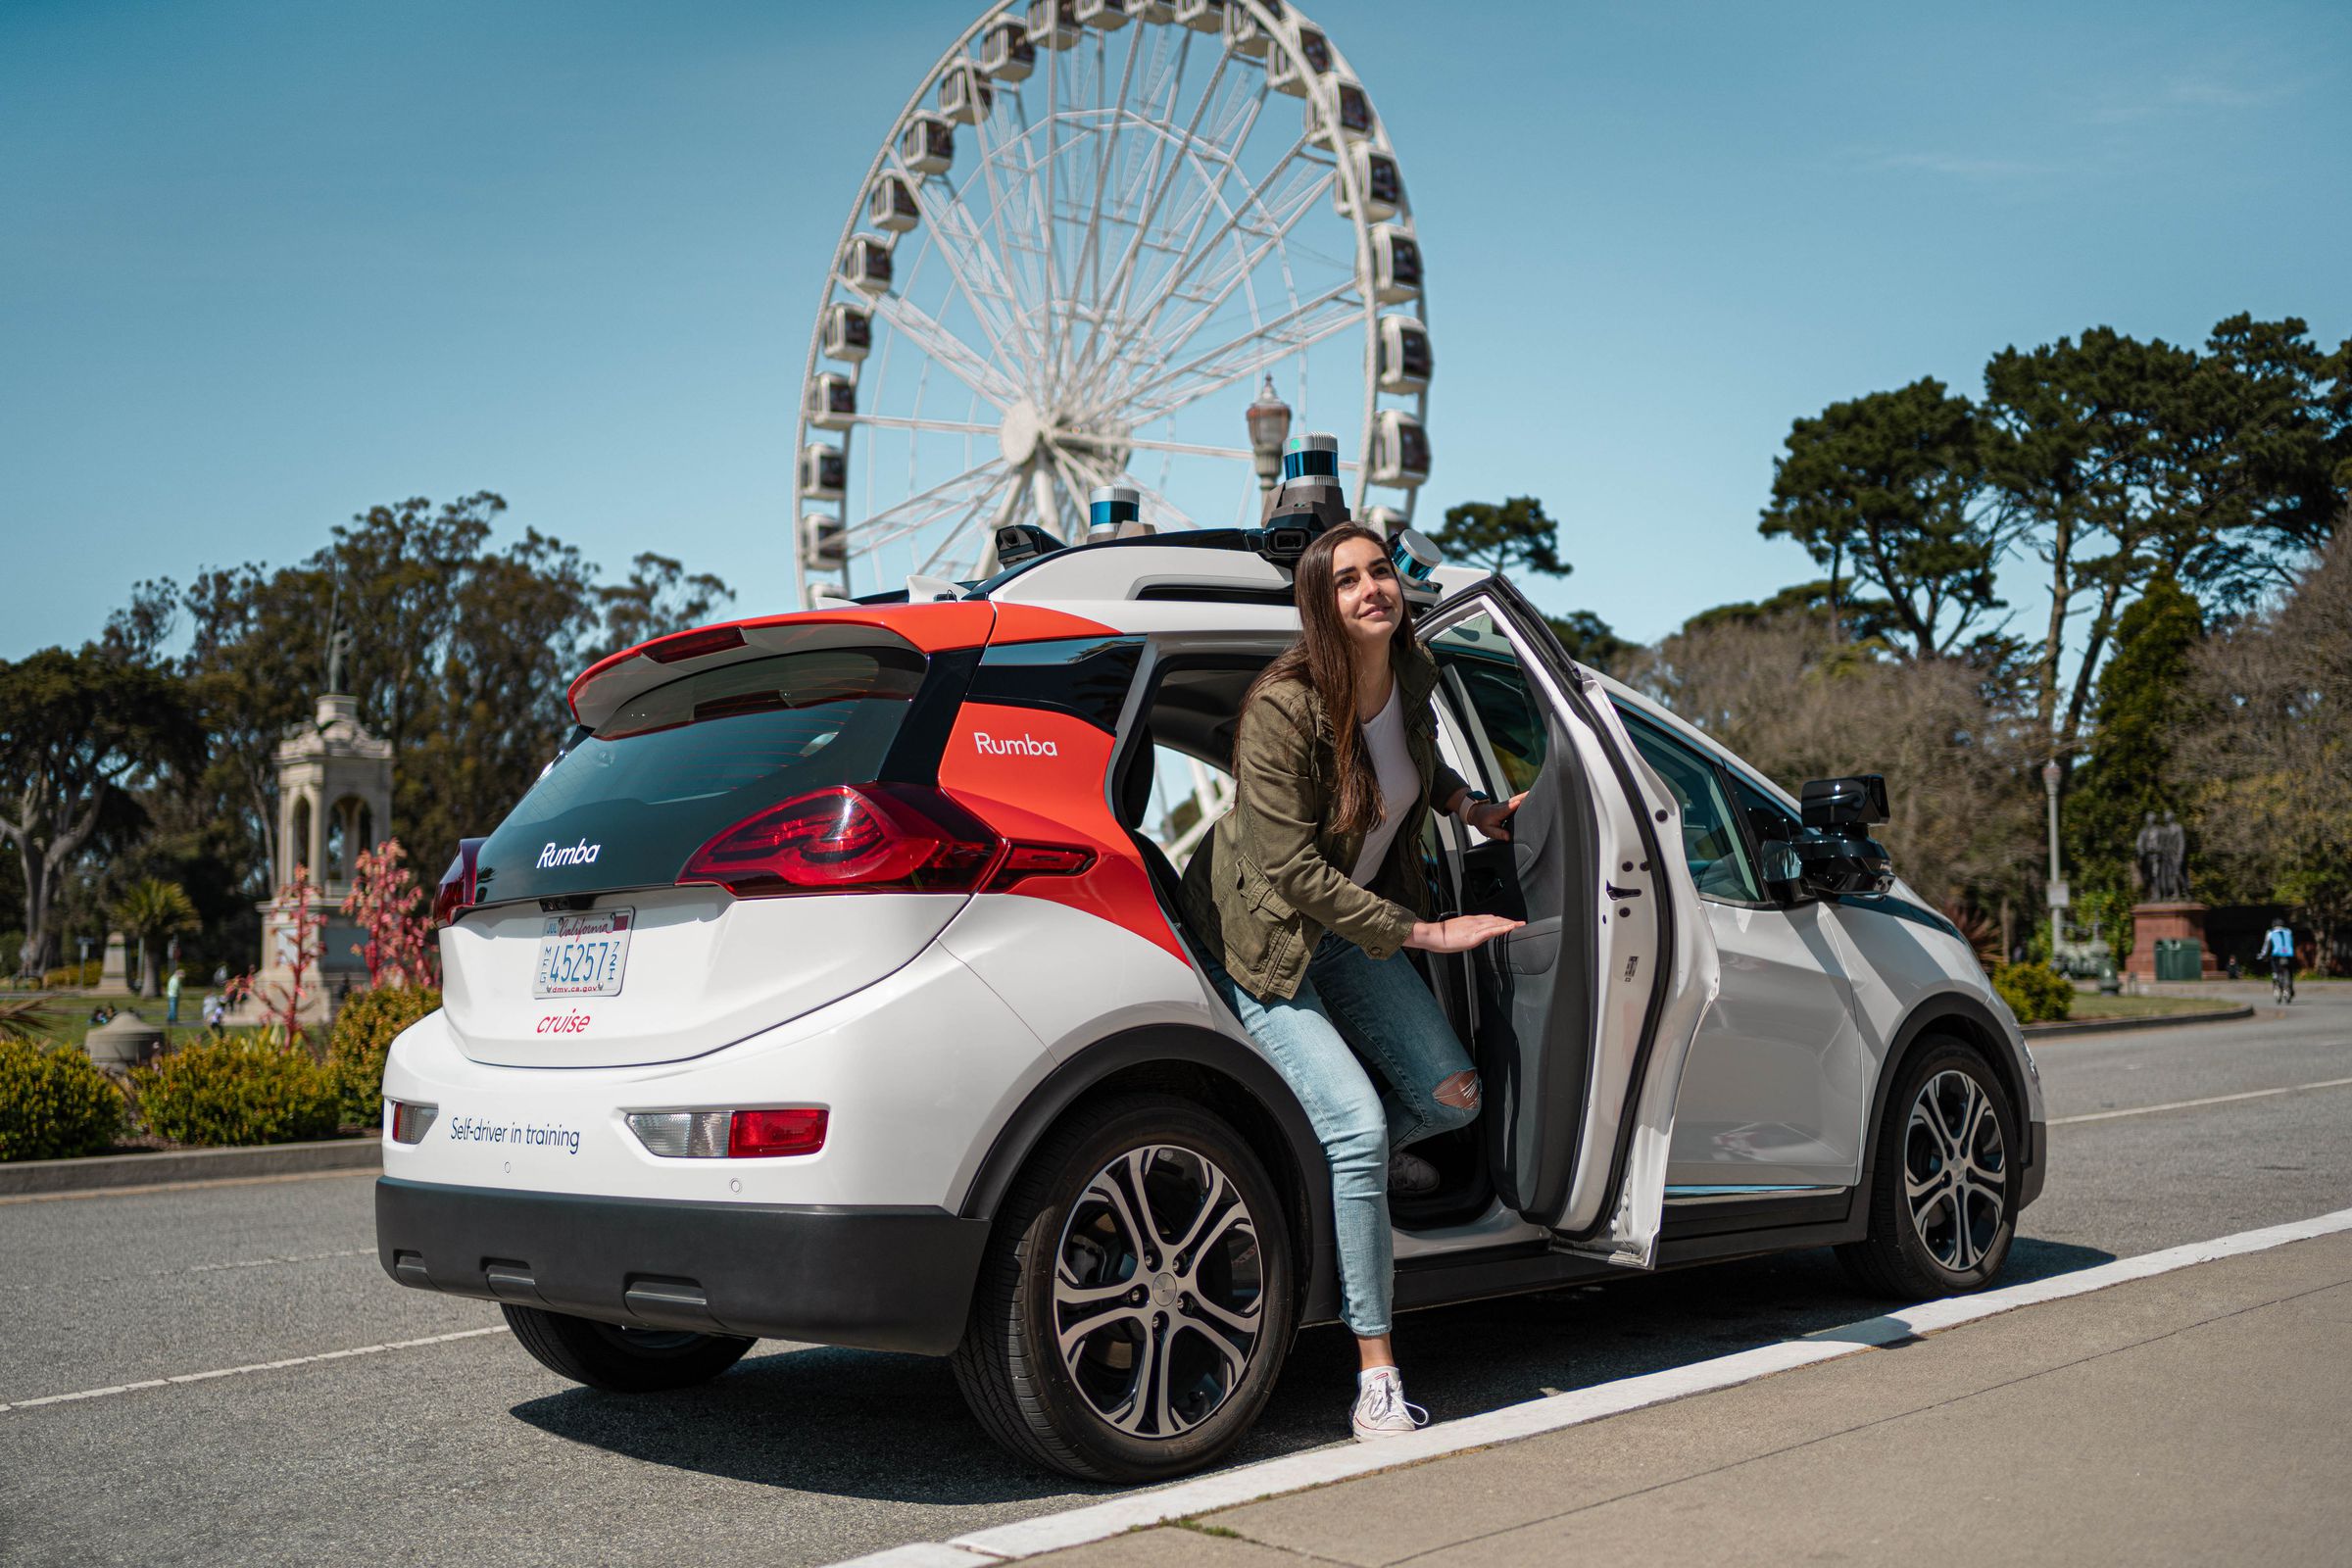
[951,1096,1298,1481]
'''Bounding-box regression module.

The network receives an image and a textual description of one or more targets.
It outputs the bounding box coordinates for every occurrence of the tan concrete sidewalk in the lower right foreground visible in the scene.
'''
[1028,1232,2352,1568]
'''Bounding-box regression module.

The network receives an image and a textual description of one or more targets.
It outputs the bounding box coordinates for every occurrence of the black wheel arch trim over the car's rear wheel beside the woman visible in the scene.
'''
[957,1022,1339,1324]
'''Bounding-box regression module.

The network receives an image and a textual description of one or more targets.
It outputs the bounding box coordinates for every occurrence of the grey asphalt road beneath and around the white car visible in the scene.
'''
[0,985,2352,1568]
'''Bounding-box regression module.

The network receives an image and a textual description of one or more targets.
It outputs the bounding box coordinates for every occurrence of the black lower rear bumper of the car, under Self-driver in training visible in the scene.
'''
[376,1175,988,1356]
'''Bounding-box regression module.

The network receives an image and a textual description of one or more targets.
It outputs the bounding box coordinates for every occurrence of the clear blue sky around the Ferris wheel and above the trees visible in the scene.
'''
[0,0,2352,656]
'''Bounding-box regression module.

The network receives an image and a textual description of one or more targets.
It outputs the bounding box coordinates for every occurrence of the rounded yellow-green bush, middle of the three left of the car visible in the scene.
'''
[131,1030,339,1145]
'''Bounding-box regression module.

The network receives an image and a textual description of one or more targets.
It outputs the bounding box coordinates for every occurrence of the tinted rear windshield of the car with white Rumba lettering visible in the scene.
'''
[475,647,924,903]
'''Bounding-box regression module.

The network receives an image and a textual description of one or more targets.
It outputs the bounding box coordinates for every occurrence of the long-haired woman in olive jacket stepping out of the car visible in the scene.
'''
[1183,526,1519,1439]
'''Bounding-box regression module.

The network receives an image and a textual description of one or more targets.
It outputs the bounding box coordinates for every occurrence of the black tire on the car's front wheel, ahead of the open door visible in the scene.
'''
[1837,1034,2023,1300]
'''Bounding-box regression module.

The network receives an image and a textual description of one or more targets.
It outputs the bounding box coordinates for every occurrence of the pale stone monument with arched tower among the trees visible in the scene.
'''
[233,625,393,1022]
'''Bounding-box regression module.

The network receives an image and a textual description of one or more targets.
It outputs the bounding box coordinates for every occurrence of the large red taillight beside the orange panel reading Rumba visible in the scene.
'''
[677,783,1004,896]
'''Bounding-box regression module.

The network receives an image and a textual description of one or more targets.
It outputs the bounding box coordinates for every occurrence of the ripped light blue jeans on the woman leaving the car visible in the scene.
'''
[1195,933,1477,1338]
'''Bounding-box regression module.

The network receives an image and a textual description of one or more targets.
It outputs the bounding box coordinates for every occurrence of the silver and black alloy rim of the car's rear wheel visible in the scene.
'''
[1054,1145,1265,1439]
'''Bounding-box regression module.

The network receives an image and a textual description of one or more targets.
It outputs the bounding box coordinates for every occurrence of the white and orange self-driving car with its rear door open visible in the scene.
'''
[376,531,2046,1479]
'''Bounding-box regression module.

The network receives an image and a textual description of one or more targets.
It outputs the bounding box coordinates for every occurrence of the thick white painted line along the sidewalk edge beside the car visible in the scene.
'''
[833,1208,2352,1568]
